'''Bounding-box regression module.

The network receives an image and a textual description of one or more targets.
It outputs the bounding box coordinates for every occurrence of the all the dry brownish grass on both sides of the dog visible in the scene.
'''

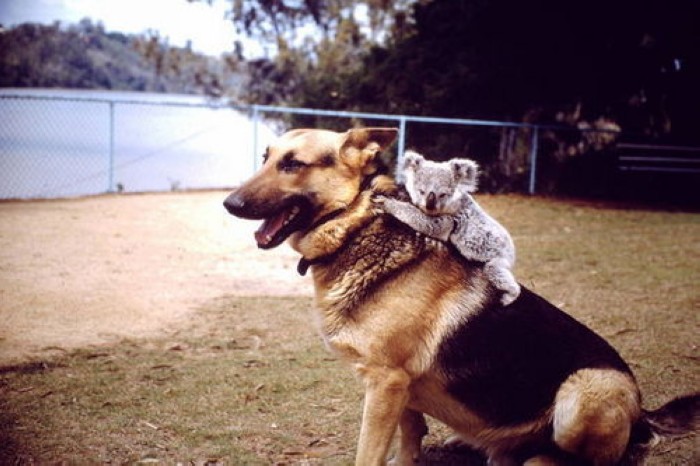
[0,196,700,465]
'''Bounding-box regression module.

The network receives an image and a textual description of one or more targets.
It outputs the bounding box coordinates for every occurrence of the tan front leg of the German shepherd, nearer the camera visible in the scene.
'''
[355,365,411,466]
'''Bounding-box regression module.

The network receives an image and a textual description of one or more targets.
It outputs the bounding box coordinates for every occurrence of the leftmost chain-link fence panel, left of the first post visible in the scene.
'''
[0,93,109,198]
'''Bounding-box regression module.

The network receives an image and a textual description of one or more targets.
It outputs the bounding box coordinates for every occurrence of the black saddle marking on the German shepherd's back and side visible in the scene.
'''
[438,287,631,425]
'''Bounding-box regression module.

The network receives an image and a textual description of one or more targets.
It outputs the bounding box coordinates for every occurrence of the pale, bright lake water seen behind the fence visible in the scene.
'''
[0,89,275,199]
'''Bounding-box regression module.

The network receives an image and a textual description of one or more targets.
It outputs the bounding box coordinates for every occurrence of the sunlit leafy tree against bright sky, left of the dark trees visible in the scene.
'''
[191,0,413,106]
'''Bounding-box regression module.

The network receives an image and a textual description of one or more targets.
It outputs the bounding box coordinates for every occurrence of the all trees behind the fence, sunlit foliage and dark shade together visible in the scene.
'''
[198,0,700,195]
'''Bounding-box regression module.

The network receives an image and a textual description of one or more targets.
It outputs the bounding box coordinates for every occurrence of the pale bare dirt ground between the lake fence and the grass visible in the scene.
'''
[0,191,312,366]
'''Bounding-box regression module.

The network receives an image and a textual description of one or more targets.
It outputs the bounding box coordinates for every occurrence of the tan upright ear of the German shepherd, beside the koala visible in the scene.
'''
[339,128,398,175]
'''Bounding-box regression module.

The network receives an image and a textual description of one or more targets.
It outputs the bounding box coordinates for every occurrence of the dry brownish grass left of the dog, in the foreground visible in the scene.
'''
[0,298,361,464]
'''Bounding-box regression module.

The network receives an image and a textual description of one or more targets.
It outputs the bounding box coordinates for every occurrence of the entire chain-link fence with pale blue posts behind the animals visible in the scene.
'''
[9,89,700,199]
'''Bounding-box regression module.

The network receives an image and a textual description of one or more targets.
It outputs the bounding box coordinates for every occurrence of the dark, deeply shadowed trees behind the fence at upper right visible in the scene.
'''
[329,0,700,189]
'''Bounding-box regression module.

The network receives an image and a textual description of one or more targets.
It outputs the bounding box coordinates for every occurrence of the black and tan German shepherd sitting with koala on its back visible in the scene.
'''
[224,128,700,466]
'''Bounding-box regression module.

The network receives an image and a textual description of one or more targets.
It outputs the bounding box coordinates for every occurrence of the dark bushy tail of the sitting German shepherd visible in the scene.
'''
[622,392,700,465]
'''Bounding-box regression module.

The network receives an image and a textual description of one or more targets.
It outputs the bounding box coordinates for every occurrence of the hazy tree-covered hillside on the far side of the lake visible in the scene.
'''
[0,19,245,99]
